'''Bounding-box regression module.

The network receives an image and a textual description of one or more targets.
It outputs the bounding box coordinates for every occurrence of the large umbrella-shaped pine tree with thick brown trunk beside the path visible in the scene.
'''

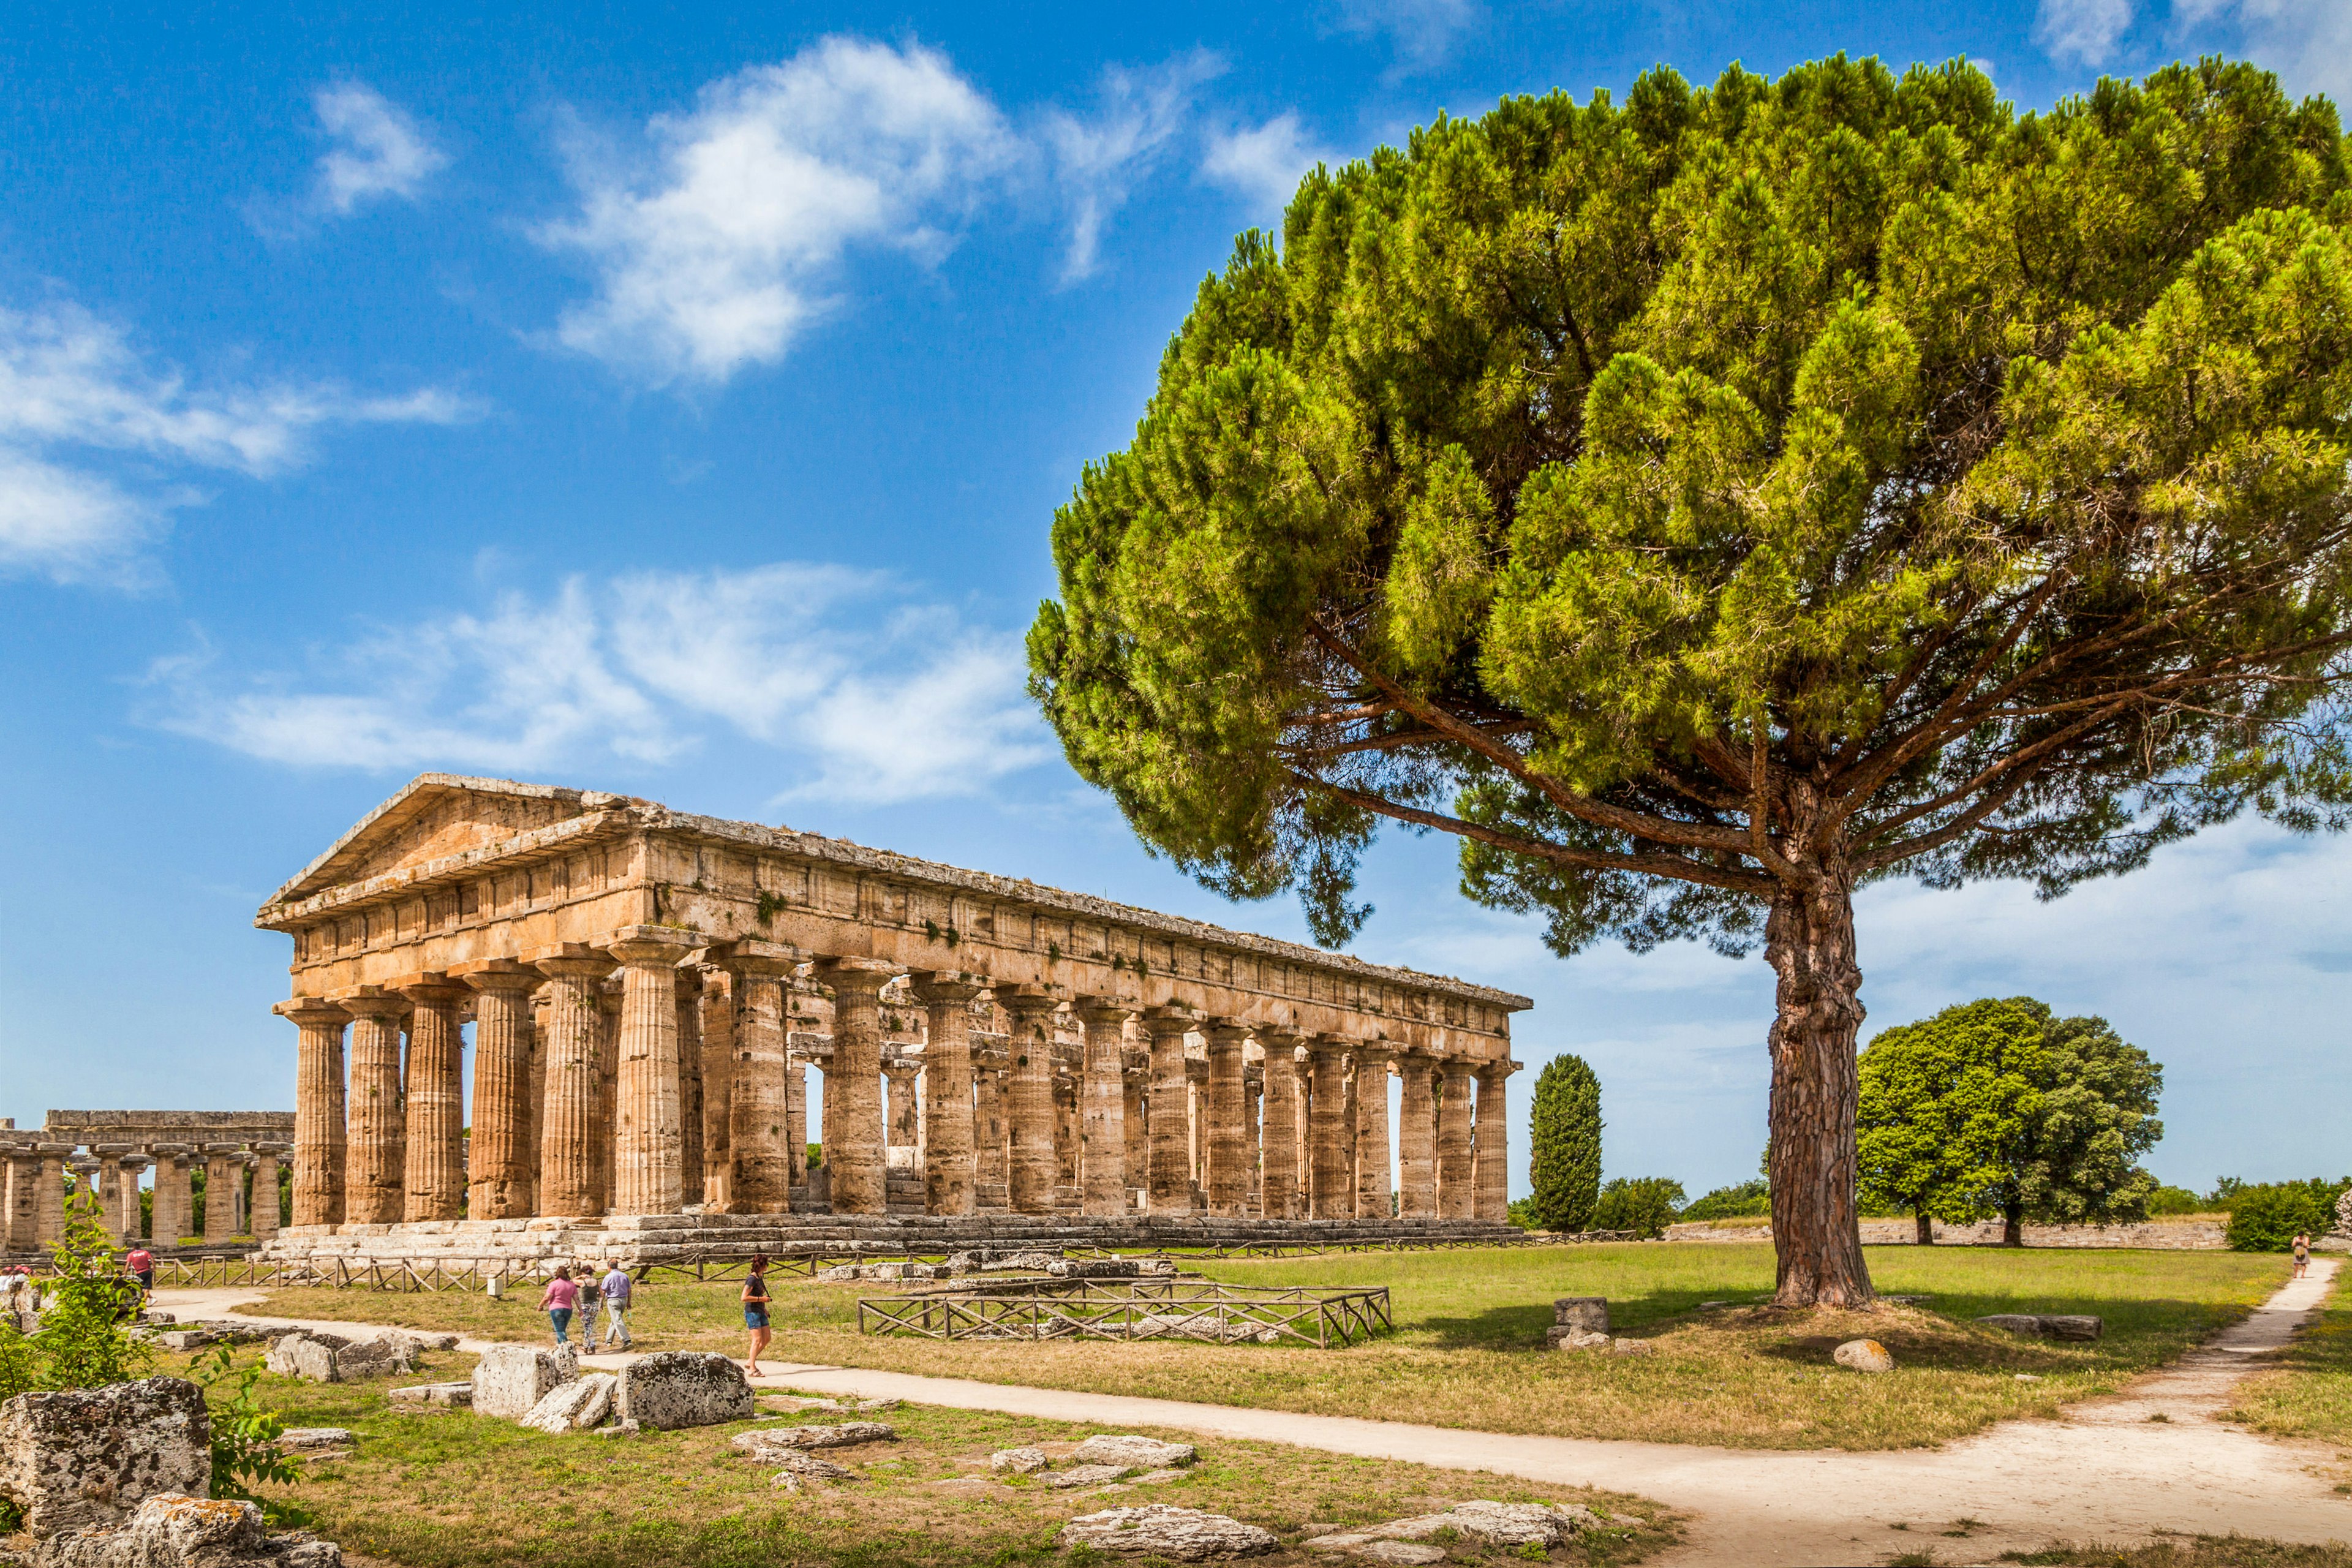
[1030,56,2352,1305]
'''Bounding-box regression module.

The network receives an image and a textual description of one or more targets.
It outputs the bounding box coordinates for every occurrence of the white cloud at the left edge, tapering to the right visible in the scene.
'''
[0,303,473,586]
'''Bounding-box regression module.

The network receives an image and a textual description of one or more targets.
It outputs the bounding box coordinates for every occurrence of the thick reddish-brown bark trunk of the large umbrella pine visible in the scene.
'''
[1764,863,1874,1307]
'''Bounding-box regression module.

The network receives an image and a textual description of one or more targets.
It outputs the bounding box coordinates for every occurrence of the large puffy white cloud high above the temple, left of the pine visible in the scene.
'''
[543,37,1016,383]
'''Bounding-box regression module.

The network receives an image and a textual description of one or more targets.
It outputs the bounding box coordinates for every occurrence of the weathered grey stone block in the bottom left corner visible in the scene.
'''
[0,1378,212,1535]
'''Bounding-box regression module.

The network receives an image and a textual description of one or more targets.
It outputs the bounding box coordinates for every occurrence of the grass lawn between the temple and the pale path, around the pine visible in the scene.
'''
[248,1243,2286,1448]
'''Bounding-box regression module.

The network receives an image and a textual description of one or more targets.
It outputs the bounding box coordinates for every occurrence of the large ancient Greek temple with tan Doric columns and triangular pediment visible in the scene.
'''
[254,774,1529,1251]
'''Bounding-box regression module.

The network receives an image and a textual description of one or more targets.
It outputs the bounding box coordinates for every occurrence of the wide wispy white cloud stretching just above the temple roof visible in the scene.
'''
[143,562,1051,804]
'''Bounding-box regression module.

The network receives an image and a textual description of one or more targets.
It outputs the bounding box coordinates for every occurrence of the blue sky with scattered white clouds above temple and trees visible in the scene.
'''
[0,0,2352,1194]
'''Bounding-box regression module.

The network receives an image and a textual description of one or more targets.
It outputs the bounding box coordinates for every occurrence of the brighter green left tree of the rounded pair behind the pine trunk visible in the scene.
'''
[1856,997,2049,1246]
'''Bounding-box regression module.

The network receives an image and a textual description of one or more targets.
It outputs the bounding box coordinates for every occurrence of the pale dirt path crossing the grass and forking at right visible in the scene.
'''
[157,1260,2352,1568]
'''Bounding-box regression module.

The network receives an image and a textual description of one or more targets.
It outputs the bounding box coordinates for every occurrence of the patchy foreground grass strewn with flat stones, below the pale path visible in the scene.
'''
[157,1354,1677,1568]
